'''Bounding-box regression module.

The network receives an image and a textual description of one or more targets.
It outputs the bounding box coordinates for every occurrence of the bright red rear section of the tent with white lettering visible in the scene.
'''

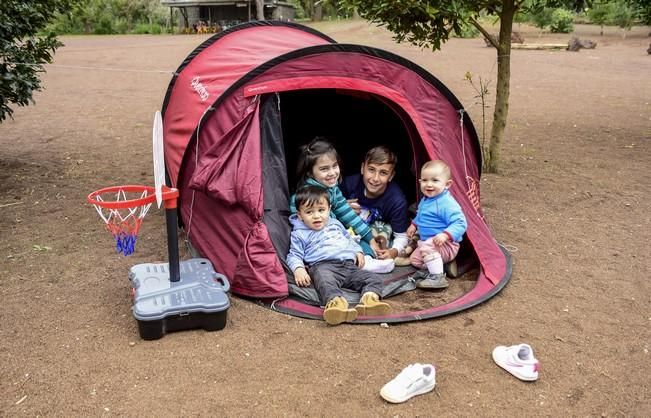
[162,21,334,186]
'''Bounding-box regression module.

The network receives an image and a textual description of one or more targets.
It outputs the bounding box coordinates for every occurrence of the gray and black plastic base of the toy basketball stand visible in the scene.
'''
[129,258,230,340]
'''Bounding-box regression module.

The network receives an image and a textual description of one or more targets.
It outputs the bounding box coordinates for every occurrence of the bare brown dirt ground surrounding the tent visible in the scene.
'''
[0,22,651,417]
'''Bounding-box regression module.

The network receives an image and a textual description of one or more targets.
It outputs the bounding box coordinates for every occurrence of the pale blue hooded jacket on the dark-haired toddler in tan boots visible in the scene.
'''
[287,214,363,272]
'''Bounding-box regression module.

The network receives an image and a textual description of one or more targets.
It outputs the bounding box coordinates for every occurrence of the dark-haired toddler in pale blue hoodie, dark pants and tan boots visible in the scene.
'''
[287,185,391,325]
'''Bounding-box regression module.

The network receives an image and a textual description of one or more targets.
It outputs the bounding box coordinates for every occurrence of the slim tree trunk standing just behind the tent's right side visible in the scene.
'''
[484,0,515,173]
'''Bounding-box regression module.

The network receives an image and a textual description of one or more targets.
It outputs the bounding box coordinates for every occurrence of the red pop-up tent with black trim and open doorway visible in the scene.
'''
[163,21,511,322]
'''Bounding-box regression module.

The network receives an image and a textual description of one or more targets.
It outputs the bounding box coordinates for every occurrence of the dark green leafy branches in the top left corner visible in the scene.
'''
[0,0,79,122]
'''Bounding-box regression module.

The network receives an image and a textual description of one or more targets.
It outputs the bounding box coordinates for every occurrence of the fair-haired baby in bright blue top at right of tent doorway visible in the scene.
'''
[407,160,468,289]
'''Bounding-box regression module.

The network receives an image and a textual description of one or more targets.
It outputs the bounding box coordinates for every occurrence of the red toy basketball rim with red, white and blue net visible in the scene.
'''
[88,186,179,256]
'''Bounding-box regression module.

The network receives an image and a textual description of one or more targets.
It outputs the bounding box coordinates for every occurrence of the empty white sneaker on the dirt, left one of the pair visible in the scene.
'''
[380,363,436,403]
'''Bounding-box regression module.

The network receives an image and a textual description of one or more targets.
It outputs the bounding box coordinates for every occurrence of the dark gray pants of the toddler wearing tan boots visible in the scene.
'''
[309,260,382,305]
